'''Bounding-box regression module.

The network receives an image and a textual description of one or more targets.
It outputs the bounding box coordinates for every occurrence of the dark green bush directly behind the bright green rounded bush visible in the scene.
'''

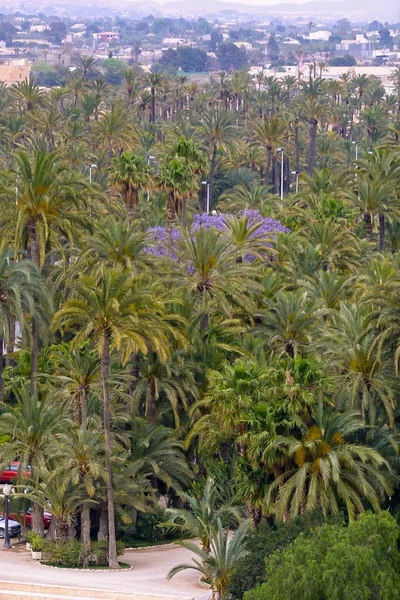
[229,512,343,600]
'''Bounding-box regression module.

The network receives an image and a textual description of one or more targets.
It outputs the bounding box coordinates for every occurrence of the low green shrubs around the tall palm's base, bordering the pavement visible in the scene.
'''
[43,540,124,567]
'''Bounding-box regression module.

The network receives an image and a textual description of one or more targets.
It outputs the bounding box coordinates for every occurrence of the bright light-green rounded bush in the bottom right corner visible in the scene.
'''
[244,511,400,600]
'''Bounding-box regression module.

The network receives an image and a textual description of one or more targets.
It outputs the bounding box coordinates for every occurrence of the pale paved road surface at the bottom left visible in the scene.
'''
[0,545,208,597]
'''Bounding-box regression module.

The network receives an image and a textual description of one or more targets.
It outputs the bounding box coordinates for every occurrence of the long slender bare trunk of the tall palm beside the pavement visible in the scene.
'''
[101,332,118,569]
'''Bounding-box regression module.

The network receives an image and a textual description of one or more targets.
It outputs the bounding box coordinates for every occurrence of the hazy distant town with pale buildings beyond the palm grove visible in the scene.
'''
[0,11,400,88]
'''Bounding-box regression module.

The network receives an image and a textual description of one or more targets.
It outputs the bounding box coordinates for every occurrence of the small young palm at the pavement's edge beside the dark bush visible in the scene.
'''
[167,520,250,600]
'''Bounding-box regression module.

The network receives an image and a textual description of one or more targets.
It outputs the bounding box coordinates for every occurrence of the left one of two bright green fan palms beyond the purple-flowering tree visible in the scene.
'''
[110,150,151,224]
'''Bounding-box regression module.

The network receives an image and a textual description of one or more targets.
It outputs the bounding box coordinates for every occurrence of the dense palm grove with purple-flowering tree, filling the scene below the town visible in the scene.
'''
[0,62,400,597]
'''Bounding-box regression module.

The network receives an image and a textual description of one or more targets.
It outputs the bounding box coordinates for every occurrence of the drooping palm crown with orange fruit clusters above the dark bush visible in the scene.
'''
[267,410,392,521]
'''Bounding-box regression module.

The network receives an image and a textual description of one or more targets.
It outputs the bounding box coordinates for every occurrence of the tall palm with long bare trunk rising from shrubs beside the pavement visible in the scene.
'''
[53,267,173,567]
